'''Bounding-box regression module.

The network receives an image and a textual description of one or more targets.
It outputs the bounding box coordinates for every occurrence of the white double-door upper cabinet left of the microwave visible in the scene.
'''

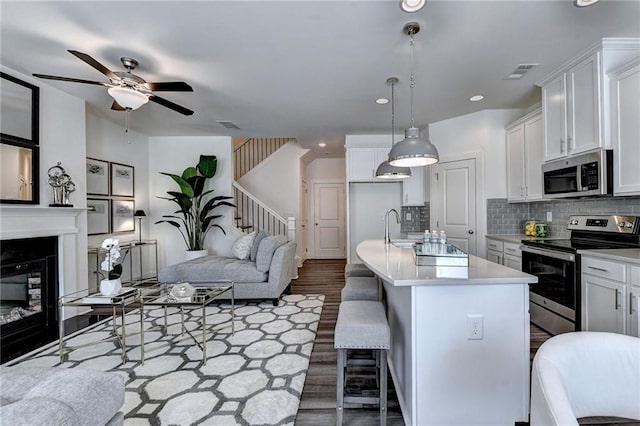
[506,110,543,201]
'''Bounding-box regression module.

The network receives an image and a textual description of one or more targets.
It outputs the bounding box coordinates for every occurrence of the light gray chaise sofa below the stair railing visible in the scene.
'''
[158,235,297,305]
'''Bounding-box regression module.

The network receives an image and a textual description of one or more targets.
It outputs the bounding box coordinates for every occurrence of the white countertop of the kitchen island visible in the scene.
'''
[356,240,538,286]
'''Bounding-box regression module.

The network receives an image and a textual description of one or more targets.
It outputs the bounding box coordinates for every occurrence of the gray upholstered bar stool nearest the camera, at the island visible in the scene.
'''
[334,300,391,425]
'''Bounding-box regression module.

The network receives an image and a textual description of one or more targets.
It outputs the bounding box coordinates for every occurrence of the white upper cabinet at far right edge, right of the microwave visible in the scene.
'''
[610,59,640,195]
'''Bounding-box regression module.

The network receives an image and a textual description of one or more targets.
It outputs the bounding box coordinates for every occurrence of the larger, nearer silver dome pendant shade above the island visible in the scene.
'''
[389,127,440,167]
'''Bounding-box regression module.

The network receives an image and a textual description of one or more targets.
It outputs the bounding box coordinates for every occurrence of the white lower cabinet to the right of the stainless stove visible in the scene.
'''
[581,256,640,336]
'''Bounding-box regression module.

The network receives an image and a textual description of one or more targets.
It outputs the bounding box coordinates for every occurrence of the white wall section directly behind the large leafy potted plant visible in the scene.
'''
[147,136,238,268]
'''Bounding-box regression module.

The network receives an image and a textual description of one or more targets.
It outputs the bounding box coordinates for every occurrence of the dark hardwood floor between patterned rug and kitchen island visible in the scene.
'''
[291,259,551,426]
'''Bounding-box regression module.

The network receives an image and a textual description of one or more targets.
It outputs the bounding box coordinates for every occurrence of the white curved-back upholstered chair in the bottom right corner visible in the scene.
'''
[530,331,640,426]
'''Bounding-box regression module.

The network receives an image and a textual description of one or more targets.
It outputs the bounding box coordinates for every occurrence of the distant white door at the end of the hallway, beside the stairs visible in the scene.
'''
[313,182,345,259]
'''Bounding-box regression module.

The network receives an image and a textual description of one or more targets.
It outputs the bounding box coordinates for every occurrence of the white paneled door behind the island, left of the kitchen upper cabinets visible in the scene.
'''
[431,158,477,255]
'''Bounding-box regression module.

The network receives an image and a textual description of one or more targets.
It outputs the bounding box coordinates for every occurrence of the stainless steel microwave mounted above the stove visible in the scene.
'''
[542,149,613,198]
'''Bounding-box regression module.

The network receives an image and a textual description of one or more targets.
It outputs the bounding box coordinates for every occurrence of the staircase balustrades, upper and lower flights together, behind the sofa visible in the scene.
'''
[233,138,295,241]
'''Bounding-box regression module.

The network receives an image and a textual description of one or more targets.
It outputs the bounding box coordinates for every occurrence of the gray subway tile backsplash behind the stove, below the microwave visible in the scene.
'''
[484,197,640,238]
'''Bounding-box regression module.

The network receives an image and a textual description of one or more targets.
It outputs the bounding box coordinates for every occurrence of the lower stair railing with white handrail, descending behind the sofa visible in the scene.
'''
[232,182,296,241]
